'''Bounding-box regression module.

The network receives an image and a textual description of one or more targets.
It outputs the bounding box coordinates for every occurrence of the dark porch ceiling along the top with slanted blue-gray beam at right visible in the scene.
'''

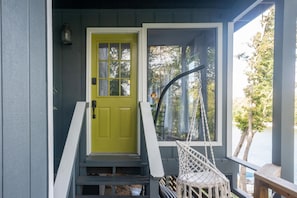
[52,0,275,23]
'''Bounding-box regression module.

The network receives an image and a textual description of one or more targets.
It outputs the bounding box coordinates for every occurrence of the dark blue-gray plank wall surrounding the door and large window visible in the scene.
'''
[53,9,230,173]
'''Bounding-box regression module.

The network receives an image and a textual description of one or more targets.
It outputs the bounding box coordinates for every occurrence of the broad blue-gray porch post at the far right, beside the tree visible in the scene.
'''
[272,0,296,182]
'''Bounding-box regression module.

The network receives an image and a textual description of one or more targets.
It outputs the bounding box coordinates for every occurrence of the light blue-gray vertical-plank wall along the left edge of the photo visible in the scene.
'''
[0,0,48,198]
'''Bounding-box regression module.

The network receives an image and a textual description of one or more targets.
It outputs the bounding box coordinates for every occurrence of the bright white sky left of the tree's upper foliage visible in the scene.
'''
[233,16,261,98]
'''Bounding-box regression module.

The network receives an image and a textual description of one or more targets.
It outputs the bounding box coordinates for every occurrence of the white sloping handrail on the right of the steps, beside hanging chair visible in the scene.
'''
[140,102,164,178]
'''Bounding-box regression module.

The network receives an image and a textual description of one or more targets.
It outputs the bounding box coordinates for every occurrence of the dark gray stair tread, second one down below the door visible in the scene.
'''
[76,175,149,185]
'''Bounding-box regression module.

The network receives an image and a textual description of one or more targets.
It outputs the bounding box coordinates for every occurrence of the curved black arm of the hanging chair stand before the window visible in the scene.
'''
[154,65,205,126]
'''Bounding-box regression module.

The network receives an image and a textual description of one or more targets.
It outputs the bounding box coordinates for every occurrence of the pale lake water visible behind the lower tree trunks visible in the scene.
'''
[232,126,297,184]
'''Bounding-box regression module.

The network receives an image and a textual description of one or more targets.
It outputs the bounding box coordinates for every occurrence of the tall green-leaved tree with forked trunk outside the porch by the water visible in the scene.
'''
[233,7,274,190]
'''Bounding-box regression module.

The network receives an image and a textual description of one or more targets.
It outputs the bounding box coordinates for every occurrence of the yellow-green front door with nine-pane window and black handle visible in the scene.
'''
[90,34,137,154]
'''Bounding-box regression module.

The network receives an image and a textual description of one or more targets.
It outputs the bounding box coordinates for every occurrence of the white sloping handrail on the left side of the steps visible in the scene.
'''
[54,102,86,198]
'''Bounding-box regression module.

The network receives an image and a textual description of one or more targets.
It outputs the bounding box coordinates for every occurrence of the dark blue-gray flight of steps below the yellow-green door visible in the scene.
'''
[76,156,150,198]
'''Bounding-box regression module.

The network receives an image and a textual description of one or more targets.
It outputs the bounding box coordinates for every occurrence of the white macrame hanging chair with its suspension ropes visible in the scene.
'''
[176,72,232,198]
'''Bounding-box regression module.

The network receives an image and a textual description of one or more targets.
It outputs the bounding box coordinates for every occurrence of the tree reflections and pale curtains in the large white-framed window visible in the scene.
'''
[148,29,216,141]
